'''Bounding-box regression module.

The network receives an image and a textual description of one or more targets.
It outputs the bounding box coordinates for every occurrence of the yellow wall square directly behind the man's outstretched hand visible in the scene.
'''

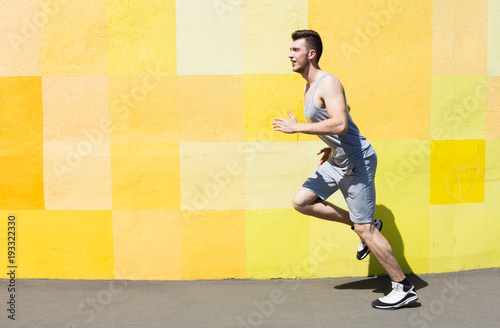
[243,74,305,142]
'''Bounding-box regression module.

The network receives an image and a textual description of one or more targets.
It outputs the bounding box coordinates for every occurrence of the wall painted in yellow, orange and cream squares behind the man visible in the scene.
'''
[0,0,500,280]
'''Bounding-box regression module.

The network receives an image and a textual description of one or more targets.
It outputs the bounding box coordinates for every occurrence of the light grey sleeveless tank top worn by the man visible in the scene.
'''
[304,73,375,167]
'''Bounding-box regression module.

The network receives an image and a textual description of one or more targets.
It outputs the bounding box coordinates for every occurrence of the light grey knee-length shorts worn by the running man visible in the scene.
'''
[301,154,377,223]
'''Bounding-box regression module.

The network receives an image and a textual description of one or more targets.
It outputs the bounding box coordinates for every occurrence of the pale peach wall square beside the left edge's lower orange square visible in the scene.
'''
[43,141,111,210]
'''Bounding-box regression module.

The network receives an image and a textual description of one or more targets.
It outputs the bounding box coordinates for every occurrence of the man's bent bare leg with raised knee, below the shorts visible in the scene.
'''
[293,189,353,226]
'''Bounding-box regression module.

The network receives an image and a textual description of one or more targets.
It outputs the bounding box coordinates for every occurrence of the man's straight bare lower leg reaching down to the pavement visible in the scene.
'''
[354,223,405,282]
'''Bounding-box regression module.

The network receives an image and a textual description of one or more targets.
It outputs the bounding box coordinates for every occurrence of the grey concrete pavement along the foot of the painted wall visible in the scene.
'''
[0,268,500,328]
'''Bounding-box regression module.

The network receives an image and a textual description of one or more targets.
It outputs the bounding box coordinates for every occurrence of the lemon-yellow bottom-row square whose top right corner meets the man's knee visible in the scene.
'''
[246,209,310,279]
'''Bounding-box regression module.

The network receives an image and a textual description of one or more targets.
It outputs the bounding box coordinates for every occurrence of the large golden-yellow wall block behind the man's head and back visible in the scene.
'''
[309,0,432,140]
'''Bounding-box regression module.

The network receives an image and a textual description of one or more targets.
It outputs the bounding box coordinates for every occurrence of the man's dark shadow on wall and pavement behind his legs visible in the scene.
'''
[335,205,429,293]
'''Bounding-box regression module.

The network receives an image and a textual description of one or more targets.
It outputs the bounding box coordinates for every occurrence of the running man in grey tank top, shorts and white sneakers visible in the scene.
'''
[272,30,418,309]
